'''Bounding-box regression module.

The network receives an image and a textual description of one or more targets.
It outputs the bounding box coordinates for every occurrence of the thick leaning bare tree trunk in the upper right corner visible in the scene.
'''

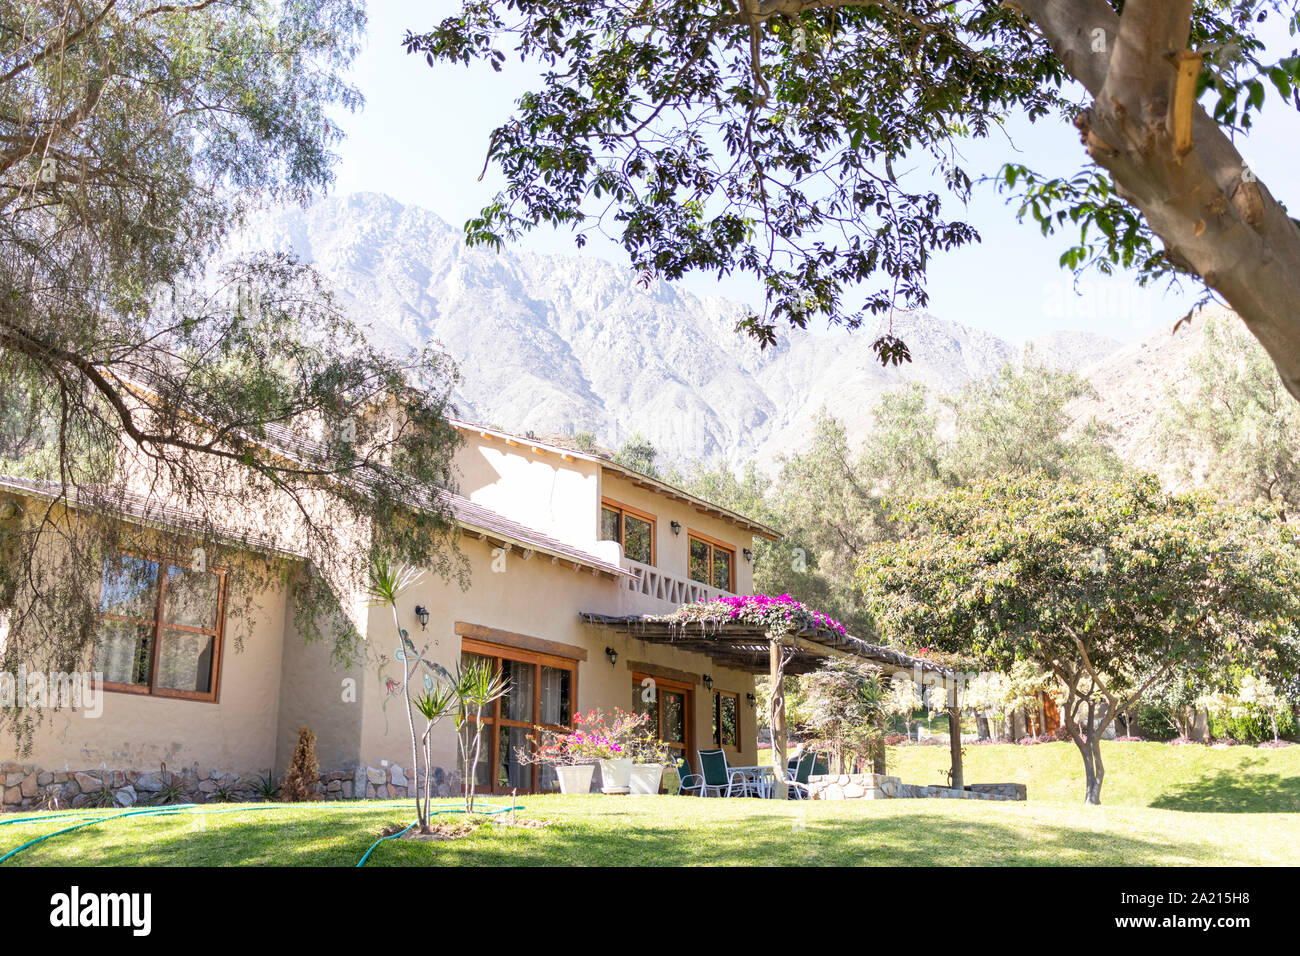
[1010,0,1300,398]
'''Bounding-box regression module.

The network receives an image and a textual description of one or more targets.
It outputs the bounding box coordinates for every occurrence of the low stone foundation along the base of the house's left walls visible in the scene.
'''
[0,762,462,810]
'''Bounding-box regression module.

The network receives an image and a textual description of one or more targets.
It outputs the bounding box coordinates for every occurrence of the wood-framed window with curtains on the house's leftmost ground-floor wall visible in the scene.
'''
[94,554,226,701]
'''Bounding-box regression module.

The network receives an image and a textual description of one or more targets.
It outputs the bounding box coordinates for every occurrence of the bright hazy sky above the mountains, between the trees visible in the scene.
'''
[335,0,1300,342]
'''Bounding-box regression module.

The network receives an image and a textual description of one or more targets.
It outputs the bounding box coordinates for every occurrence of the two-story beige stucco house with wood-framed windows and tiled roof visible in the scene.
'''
[0,421,777,806]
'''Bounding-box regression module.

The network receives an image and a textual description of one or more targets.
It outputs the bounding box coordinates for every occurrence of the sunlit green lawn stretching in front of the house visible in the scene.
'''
[0,744,1300,866]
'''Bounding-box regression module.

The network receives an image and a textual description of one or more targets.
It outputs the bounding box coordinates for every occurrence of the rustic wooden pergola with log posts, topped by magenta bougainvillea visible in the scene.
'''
[579,611,965,799]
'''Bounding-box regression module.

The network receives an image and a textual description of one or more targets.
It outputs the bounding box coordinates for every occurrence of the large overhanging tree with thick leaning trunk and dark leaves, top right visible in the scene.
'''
[406,0,1300,397]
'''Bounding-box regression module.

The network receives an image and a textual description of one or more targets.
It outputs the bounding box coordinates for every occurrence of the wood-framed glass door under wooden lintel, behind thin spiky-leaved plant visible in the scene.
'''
[460,640,576,793]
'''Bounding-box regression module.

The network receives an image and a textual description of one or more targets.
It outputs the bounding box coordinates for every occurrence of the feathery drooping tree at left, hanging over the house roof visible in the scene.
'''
[0,0,459,747]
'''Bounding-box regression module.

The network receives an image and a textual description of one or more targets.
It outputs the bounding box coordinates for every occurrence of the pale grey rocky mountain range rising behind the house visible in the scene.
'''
[235,194,1131,463]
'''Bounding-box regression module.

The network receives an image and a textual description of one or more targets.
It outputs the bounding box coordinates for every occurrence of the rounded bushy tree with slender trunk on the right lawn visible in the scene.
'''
[859,475,1300,804]
